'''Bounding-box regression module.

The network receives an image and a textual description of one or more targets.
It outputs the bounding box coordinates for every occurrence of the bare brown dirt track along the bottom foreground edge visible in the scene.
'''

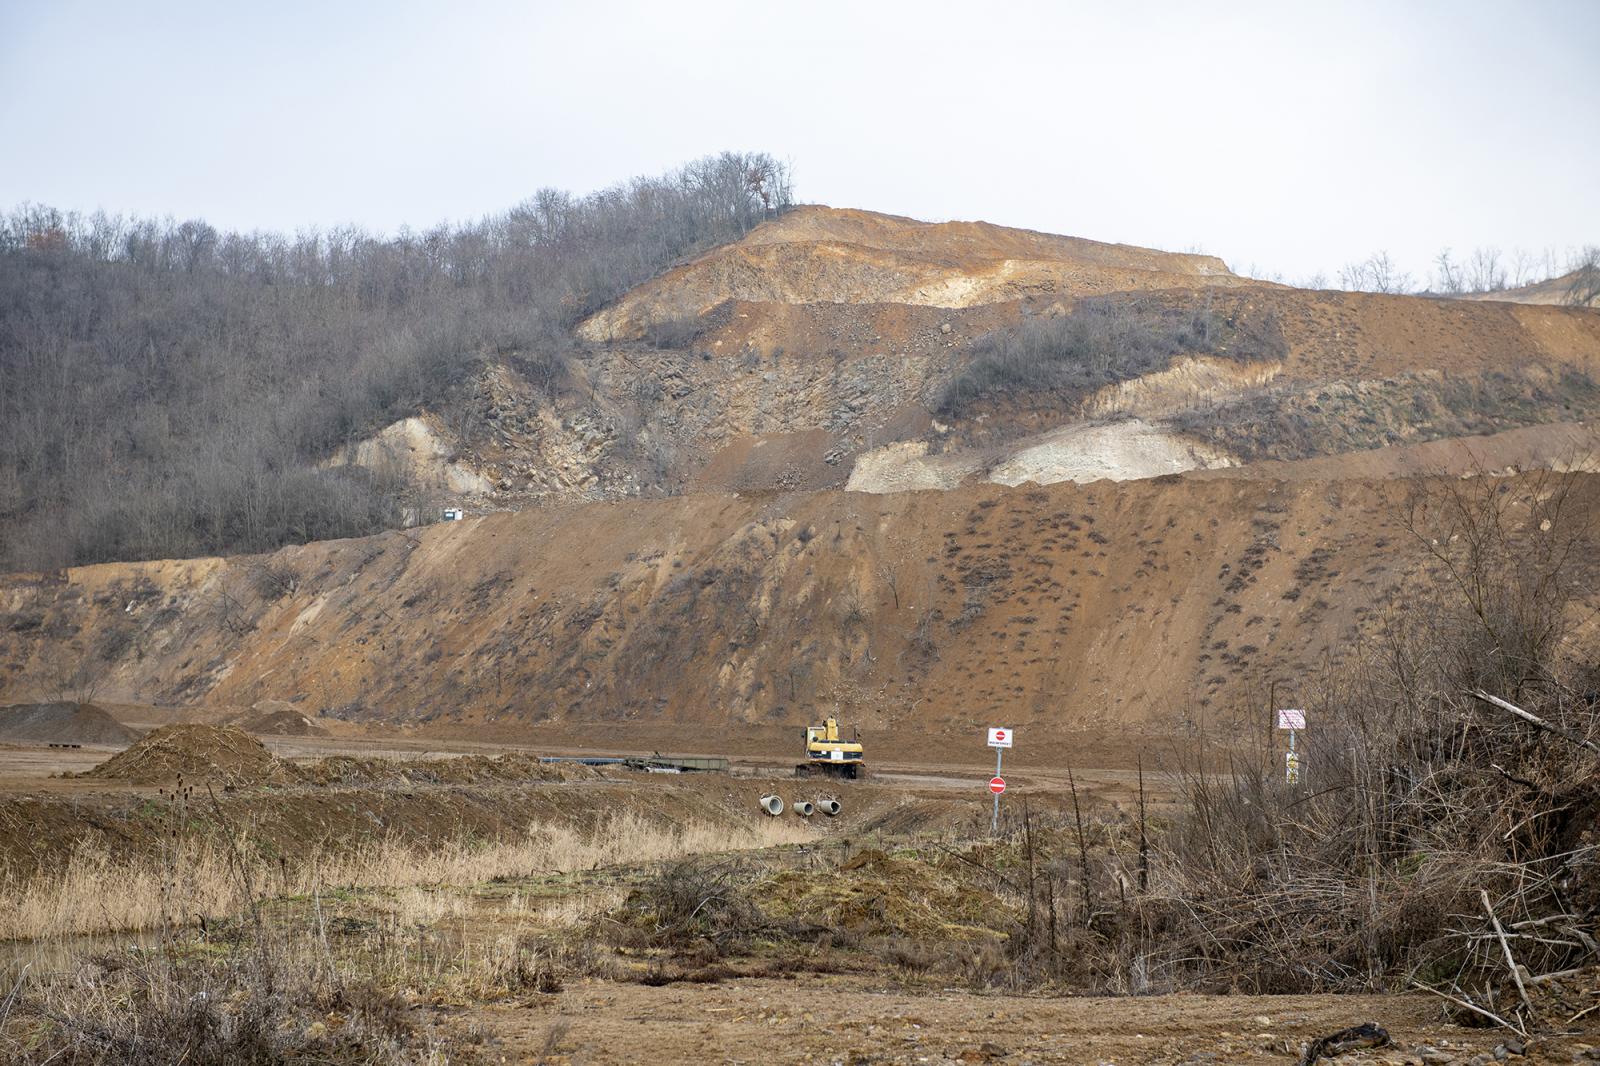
[472,975,1536,1066]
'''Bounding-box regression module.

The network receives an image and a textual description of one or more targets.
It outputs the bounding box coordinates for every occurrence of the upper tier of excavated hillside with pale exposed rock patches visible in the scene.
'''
[324,208,1600,509]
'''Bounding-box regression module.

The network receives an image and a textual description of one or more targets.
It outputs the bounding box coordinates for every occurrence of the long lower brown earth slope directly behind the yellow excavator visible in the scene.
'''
[0,475,1600,736]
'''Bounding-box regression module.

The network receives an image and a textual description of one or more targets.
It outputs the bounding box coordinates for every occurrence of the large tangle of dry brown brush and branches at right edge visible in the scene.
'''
[1139,475,1600,1021]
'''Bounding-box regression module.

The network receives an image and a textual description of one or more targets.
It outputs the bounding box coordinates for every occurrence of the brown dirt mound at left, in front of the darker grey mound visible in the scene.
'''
[85,722,298,786]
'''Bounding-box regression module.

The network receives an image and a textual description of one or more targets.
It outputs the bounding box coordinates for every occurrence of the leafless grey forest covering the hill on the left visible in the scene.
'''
[0,152,792,570]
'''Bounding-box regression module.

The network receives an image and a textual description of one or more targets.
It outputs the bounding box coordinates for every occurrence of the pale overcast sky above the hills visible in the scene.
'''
[0,0,1600,280]
